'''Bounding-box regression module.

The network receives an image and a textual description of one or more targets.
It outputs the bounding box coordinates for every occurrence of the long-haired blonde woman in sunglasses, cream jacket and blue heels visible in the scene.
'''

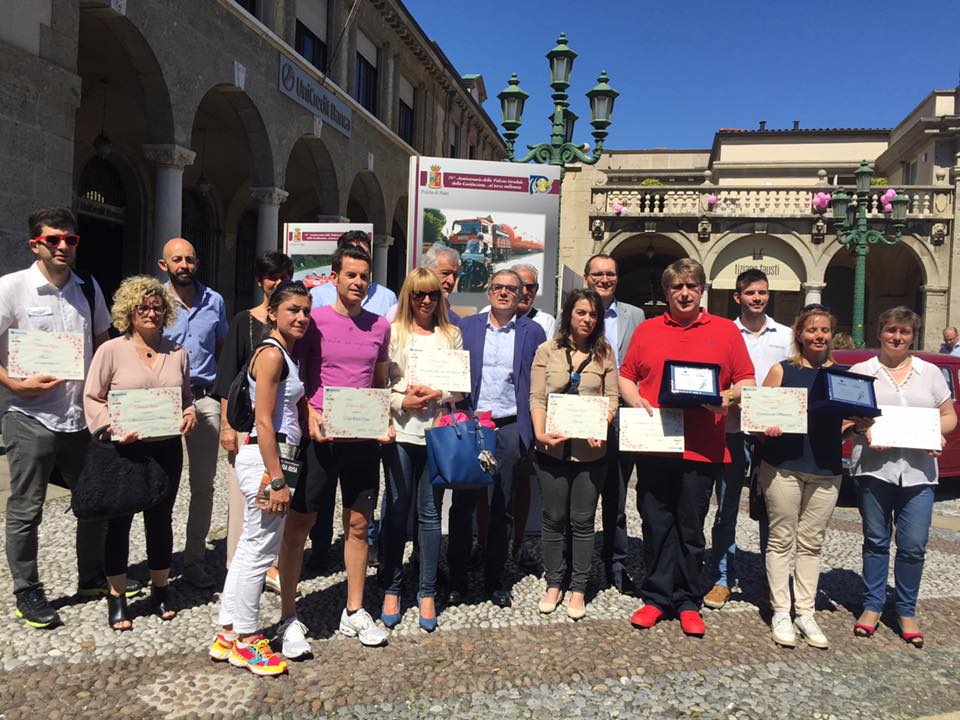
[380,268,463,632]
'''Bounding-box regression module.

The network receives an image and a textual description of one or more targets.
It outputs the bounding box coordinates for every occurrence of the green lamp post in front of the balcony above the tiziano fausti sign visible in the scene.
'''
[830,160,910,348]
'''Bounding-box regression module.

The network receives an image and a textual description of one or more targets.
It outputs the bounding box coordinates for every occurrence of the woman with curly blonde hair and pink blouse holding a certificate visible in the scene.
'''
[83,275,197,631]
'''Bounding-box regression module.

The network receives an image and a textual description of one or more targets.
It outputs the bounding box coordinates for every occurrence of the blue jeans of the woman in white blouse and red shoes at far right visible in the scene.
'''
[856,475,936,617]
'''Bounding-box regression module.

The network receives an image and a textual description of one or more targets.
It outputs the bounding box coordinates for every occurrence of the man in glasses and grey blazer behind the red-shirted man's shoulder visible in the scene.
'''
[583,254,644,594]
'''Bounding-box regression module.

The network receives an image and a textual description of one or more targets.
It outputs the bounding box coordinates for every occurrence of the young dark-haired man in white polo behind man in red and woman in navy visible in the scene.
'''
[703,268,793,610]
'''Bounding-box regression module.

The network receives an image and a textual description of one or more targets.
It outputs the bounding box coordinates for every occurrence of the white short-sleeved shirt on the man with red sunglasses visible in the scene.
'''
[0,263,110,432]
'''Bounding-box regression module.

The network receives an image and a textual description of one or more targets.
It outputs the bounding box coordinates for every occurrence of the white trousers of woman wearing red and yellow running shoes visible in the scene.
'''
[218,445,284,635]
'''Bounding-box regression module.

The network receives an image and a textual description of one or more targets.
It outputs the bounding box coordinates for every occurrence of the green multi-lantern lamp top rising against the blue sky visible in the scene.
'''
[497,33,620,172]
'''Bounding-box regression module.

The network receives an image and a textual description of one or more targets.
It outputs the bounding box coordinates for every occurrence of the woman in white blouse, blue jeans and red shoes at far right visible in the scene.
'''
[851,307,957,647]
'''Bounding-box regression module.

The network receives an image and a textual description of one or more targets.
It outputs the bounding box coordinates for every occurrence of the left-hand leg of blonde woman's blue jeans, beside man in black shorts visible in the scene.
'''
[380,443,427,595]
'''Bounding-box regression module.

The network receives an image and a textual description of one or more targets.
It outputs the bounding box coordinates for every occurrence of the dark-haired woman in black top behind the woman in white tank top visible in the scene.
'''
[212,252,293,593]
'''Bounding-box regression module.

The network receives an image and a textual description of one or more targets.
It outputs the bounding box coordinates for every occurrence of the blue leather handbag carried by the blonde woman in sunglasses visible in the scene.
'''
[425,410,497,490]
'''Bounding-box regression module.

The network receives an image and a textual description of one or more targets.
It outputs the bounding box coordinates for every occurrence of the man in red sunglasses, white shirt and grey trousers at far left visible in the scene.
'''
[0,207,110,628]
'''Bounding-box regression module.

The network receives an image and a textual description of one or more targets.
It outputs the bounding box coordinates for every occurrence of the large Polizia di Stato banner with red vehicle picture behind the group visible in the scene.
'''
[407,157,560,313]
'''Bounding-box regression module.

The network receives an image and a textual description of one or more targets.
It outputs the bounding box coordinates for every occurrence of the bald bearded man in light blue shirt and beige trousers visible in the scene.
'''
[157,238,228,589]
